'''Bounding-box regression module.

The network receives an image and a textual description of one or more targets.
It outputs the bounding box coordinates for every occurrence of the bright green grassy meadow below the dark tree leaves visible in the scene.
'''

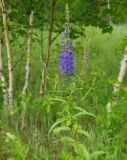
[0,24,127,160]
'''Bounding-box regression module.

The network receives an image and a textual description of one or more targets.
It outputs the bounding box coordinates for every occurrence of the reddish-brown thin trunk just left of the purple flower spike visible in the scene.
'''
[40,0,56,96]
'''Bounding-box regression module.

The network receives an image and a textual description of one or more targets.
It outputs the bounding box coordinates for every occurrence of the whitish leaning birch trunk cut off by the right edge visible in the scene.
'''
[114,46,127,92]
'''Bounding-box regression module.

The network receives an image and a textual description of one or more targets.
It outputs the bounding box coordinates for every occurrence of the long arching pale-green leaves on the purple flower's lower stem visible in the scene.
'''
[49,107,103,160]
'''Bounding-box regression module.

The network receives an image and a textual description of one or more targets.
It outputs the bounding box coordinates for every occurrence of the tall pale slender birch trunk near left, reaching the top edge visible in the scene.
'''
[1,0,13,106]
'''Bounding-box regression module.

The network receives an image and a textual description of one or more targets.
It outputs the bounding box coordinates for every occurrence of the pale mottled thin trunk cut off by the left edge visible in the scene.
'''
[0,37,7,105]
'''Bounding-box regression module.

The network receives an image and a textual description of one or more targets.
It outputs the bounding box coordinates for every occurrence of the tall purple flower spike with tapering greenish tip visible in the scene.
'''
[59,5,74,75]
